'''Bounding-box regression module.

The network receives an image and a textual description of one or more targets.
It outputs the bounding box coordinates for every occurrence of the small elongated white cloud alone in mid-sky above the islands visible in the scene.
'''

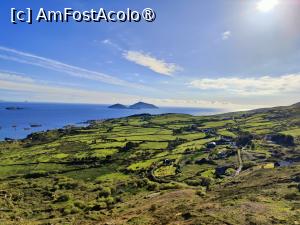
[123,51,181,76]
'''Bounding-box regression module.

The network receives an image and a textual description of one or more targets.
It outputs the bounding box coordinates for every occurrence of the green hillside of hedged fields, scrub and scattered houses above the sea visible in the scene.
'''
[0,105,300,224]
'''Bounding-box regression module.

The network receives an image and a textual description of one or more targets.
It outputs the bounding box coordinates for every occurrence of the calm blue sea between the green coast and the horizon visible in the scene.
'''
[0,102,220,140]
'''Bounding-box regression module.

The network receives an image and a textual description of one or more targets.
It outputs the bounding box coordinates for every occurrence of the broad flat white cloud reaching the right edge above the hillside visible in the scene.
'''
[190,74,300,95]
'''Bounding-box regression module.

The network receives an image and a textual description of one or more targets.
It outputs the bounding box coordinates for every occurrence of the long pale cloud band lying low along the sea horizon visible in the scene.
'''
[0,72,261,110]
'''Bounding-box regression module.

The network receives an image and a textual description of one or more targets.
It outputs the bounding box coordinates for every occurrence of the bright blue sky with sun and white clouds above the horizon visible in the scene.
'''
[0,0,300,109]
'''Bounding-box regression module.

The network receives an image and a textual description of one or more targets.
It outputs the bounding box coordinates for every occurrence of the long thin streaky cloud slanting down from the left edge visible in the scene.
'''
[0,46,140,88]
